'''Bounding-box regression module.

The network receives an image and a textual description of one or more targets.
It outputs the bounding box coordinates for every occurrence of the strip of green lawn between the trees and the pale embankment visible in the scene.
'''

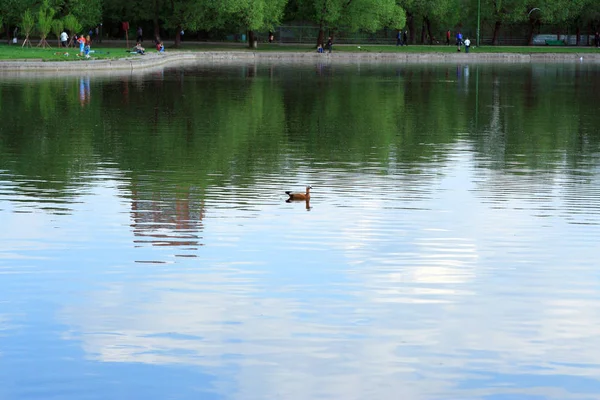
[0,40,600,61]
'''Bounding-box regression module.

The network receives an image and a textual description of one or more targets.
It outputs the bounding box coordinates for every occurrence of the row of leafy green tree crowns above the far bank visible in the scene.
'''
[8,0,600,45]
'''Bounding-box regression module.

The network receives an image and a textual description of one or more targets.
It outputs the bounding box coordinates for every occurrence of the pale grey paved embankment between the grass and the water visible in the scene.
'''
[0,51,600,73]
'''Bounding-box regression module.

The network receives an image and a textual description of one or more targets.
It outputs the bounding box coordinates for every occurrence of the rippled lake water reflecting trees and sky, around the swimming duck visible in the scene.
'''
[0,63,600,400]
